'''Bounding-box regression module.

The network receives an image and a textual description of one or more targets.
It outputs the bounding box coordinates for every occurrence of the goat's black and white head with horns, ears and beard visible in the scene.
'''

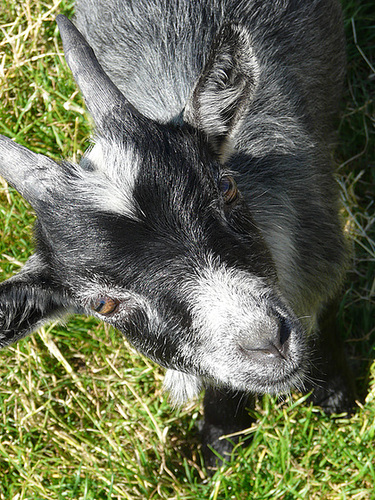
[0,16,305,401]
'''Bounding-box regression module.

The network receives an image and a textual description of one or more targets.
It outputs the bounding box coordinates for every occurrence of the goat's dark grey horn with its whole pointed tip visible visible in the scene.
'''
[56,14,134,128]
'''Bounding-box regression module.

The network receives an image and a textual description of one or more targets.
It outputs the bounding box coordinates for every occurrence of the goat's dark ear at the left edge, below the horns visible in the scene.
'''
[0,256,70,348]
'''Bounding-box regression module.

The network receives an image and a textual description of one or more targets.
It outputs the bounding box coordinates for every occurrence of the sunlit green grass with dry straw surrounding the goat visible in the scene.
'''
[0,0,375,500]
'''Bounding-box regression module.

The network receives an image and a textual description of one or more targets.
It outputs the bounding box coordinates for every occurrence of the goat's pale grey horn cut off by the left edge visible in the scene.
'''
[0,135,60,205]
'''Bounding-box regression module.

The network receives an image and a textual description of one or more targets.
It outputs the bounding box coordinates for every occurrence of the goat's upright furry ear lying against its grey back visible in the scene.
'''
[184,24,259,157]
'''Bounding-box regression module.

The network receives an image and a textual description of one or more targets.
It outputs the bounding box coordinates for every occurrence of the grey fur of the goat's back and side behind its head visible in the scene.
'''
[76,0,346,316]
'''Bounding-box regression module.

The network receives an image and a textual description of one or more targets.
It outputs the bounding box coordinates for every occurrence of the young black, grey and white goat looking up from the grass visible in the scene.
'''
[0,0,353,464]
